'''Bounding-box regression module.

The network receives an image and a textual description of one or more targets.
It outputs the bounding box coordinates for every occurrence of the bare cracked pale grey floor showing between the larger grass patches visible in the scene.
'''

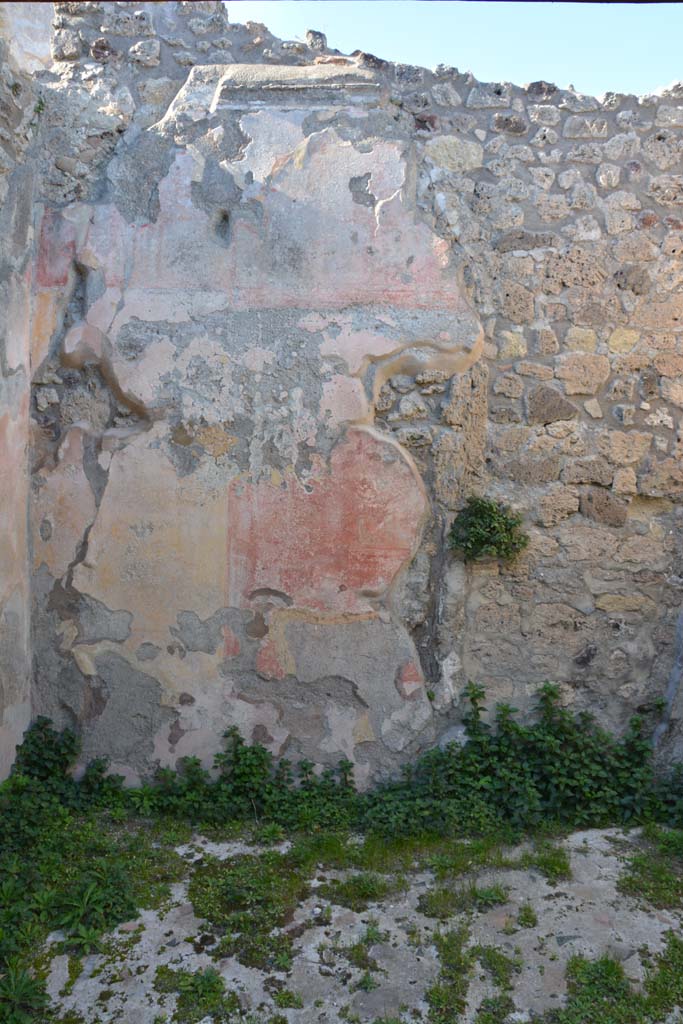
[42,829,682,1024]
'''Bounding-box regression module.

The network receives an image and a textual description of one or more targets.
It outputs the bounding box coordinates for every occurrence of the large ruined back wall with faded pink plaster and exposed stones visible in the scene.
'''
[1,3,683,782]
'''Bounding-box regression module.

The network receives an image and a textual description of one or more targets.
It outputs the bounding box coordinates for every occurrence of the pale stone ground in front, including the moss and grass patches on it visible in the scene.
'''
[40,829,683,1024]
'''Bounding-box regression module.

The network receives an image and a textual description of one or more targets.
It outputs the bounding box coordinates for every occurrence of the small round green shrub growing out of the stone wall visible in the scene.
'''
[449,497,528,562]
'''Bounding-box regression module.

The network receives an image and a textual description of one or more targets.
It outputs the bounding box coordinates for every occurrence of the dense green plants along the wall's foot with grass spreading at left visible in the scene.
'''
[0,683,683,1024]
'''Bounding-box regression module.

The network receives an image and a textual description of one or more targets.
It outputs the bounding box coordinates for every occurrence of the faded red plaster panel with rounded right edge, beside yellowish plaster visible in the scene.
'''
[227,430,427,613]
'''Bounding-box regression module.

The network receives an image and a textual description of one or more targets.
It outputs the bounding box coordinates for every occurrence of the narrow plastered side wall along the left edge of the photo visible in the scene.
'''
[0,4,49,778]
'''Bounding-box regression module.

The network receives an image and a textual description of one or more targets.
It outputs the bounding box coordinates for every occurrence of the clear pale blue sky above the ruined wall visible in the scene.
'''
[227,0,683,95]
